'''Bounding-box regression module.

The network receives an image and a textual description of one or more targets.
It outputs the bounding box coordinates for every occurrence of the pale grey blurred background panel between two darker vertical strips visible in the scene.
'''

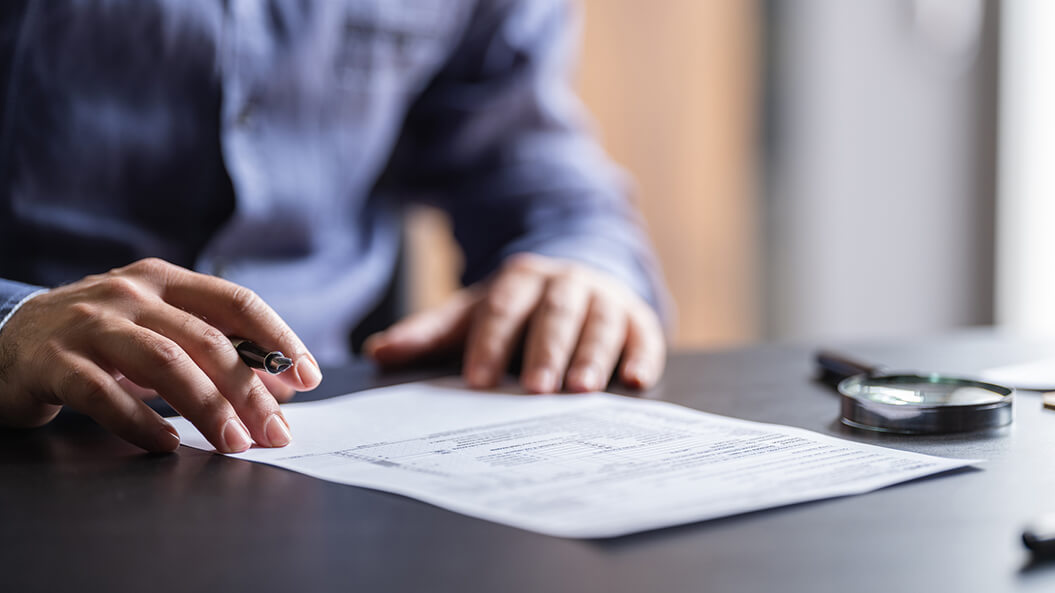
[763,0,999,338]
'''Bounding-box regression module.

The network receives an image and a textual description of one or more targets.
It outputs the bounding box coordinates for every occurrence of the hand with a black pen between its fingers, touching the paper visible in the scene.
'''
[0,260,322,453]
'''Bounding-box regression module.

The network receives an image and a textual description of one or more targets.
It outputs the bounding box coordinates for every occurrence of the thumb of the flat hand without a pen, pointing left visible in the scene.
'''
[363,290,477,366]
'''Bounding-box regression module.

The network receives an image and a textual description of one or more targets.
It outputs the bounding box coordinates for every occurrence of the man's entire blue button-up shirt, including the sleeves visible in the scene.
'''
[0,0,661,363]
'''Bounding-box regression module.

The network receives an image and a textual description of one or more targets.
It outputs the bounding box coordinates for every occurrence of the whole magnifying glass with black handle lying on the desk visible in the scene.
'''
[816,350,1015,435]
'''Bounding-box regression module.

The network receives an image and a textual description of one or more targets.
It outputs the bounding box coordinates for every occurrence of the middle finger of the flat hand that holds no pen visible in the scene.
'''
[521,274,590,394]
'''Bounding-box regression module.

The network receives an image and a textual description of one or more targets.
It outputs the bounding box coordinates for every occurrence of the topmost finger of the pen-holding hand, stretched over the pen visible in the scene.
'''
[130,260,322,390]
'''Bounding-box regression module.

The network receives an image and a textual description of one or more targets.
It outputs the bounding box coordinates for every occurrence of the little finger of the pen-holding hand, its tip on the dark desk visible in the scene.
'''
[53,353,179,453]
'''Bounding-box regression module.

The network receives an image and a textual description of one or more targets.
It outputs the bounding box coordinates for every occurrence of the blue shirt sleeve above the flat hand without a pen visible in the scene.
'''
[379,0,672,321]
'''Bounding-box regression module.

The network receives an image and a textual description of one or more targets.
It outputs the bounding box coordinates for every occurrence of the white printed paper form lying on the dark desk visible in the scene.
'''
[170,382,972,538]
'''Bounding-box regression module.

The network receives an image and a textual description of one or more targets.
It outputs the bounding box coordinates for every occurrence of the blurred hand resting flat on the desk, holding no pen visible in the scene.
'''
[365,253,666,394]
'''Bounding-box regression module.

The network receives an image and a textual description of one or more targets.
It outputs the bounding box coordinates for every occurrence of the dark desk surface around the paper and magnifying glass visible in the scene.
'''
[6,334,1055,593]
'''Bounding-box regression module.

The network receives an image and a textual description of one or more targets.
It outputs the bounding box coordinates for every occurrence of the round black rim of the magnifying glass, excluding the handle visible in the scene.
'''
[838,374,1015,435]
